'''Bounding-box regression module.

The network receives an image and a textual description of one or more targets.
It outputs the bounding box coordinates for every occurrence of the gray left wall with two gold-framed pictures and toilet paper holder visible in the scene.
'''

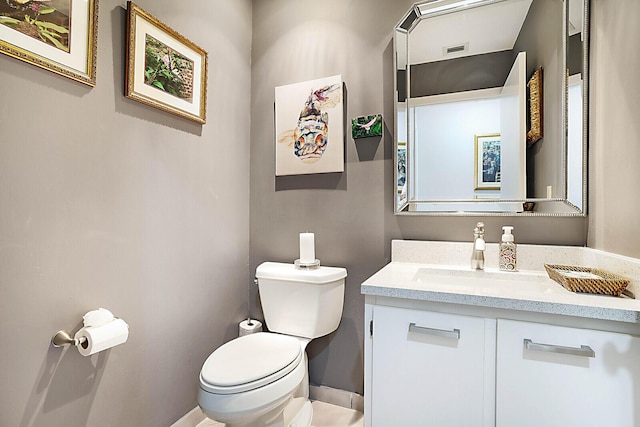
[0,0,251,427]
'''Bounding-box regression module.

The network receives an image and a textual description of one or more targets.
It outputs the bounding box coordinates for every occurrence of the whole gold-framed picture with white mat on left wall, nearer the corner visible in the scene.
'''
[125,1,207,124]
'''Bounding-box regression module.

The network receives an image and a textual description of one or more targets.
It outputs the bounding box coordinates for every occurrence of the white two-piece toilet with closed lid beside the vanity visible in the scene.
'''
[198,262,347,427]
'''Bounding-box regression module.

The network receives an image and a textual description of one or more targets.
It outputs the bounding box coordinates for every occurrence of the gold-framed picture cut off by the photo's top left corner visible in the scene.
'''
[0,0,98,86]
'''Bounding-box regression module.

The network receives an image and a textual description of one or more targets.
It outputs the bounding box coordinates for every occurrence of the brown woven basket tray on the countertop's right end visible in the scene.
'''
[544,264,629,296]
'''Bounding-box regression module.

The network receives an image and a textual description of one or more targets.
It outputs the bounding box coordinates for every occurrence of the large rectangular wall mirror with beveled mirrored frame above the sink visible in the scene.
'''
[394,0,589,216]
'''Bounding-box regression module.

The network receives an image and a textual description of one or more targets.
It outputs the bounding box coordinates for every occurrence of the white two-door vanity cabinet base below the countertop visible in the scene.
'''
[365,298,640,427]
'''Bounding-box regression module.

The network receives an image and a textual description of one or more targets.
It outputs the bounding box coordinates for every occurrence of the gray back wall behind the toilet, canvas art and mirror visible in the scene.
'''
[250,0,586,393]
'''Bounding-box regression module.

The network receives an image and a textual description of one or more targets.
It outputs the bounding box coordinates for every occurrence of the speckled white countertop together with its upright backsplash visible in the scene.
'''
[361,241,640,324]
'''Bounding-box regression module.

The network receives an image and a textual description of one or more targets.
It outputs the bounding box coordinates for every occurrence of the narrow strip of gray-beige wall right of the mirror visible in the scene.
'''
[588,0,640,258]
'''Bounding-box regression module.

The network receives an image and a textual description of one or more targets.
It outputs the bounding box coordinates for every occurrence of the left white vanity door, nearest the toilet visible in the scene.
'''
[370,306,496,427]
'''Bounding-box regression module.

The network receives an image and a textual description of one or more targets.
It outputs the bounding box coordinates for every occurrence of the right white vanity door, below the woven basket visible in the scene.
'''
[496,320,640,427]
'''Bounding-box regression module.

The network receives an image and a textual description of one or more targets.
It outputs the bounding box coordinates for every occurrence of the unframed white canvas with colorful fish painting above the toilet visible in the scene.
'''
[275,75,344,176]
